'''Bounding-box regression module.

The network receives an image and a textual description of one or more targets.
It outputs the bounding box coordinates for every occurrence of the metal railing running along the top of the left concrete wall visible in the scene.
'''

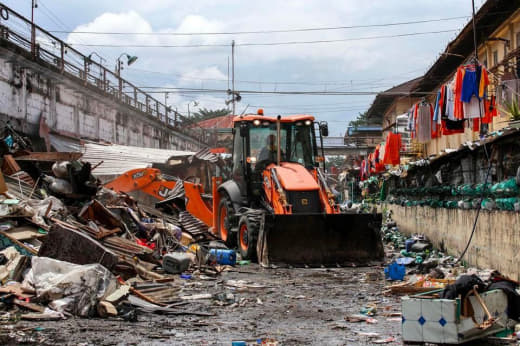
[0,3,205,141]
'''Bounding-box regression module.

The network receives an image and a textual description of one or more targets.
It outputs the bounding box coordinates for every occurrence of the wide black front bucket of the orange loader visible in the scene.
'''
[257,214,384,267]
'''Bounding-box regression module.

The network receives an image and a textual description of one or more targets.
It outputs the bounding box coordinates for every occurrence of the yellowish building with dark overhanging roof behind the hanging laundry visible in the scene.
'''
[368,0,520,157]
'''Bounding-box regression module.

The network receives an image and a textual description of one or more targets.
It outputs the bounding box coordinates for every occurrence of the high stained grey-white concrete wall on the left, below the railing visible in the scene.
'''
[0,48,201,151]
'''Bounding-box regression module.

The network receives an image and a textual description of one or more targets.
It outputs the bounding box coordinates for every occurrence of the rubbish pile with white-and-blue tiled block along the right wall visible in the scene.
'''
[382,212,520,343]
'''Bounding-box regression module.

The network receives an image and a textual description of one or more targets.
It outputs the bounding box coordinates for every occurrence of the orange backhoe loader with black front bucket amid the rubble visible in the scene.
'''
[104,112,384,266]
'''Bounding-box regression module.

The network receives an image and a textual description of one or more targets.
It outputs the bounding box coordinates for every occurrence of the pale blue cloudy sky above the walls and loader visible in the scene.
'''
[3,0,484,136]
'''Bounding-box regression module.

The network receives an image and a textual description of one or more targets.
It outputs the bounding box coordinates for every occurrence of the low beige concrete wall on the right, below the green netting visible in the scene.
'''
[387,205,520,280]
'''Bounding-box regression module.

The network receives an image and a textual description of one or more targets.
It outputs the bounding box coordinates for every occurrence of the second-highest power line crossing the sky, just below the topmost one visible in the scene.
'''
[69,29,459,48]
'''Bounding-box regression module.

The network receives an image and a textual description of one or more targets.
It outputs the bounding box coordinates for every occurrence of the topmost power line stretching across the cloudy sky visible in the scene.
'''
[50,16,469,36]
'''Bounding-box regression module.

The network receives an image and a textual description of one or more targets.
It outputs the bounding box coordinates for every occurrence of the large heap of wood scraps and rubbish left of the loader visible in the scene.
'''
[0,136,236,321]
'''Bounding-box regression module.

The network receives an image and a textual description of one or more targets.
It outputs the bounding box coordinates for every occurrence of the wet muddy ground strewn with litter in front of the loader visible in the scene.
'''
[0,264,402,345]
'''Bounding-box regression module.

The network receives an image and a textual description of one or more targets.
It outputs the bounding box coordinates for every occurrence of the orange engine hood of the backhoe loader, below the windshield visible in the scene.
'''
[268,162,320,191]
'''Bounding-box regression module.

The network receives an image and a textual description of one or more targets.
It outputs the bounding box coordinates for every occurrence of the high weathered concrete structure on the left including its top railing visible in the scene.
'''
[0,5,204,151]
